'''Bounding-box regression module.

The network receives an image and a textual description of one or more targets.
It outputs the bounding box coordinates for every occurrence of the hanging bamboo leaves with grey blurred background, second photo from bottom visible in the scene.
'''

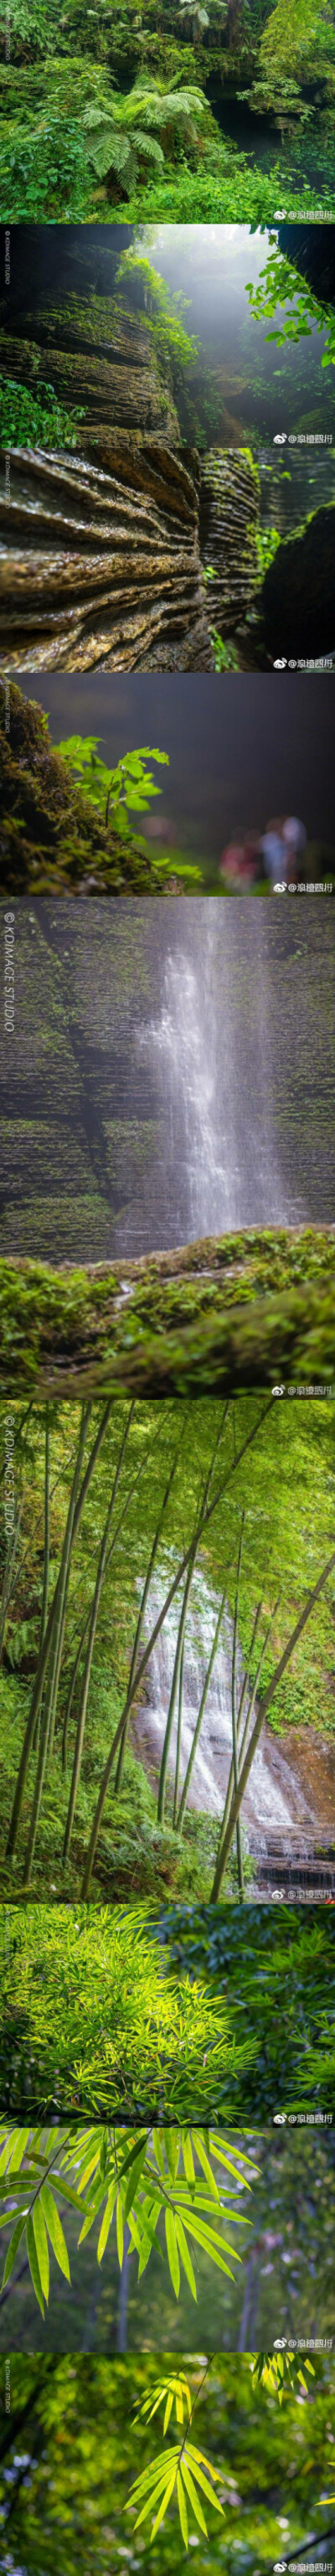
[0,2125,335,2355]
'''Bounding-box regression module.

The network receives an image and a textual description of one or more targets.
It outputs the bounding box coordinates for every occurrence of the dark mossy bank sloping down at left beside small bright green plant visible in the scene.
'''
[0,680,175,896]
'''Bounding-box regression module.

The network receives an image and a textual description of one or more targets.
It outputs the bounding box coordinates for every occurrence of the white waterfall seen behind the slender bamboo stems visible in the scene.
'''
[134,1567,335,1893]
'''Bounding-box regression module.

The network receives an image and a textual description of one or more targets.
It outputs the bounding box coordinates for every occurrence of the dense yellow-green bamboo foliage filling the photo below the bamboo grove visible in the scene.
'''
[0,1903,335,2128]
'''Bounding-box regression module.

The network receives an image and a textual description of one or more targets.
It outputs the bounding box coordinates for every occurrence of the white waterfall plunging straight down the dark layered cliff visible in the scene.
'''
[137,901,304,1249]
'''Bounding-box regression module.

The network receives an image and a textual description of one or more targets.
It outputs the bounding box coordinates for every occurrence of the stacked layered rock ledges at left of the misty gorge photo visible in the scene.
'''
[0,291,180,446]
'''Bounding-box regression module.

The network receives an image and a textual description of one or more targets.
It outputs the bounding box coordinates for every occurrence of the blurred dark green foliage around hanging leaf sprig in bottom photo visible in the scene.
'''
[0,2349,335,2576]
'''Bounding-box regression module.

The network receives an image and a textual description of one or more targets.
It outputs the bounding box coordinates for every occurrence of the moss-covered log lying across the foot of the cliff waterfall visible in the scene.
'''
[0,1226,335,1399]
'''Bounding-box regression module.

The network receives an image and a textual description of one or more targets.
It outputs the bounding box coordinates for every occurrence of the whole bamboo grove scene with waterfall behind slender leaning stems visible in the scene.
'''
[0,1396,335,1901]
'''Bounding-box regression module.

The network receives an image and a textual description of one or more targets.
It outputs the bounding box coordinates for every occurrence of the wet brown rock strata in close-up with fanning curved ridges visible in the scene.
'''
[0,433,214,670]
